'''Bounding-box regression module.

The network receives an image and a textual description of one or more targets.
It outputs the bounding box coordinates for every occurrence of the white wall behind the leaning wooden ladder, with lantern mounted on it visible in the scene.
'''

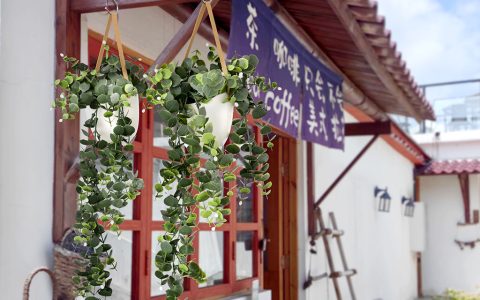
[299,113,417,300]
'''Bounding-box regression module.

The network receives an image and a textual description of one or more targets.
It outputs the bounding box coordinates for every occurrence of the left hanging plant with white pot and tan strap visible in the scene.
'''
[53,13,146,300]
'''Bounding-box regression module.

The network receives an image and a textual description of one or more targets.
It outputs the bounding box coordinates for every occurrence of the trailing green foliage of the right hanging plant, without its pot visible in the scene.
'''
[146,48,276,299]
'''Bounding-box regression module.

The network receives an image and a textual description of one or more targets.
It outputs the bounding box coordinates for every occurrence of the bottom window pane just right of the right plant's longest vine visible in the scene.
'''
[198,231,224,287]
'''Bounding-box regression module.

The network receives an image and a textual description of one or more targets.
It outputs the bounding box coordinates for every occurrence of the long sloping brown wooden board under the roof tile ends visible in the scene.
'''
[327,0,423,121]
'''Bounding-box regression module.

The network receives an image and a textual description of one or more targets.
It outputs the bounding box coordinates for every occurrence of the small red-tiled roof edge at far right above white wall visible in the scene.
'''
[421,159,480,175]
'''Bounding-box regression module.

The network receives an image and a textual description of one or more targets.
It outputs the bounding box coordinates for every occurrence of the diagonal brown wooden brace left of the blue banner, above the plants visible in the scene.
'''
[148,0,219,72]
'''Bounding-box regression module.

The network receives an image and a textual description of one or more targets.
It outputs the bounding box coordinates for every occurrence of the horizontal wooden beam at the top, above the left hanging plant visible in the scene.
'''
[70,0,193,13]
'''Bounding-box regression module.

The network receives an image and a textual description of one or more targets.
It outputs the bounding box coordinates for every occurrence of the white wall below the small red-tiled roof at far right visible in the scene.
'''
[420,175,480,295]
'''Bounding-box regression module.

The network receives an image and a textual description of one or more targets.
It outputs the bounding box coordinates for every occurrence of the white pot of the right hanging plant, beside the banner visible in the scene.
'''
[192,93,235,148]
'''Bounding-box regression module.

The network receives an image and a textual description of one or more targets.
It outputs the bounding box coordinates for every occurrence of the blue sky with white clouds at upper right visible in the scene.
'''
[377,0,480,98]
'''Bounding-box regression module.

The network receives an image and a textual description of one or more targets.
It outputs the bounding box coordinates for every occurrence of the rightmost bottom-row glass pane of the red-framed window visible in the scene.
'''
[235,231,253,280]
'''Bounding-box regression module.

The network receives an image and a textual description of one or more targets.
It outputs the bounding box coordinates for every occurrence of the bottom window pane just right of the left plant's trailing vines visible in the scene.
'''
[107,231,133,300]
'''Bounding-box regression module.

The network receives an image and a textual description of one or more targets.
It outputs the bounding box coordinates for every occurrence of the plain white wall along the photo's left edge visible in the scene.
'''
[0,0,55,300]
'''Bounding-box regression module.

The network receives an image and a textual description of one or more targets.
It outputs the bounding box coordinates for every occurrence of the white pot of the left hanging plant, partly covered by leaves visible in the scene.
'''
[97,95,140,143]
